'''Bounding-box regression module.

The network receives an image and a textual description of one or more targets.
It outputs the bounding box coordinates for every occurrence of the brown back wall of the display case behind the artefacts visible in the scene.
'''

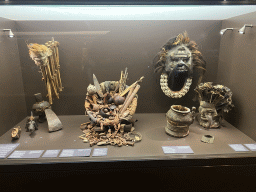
[16,21,221,115]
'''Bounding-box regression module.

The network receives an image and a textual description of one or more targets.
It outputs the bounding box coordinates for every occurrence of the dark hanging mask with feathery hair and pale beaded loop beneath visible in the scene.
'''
[153,32,205,98]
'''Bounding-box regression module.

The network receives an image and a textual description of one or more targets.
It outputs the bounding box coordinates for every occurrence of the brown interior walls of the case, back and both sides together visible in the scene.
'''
[0,13,256,139]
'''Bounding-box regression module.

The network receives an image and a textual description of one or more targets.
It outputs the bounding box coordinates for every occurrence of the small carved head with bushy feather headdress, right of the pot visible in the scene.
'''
[195,82,234,128]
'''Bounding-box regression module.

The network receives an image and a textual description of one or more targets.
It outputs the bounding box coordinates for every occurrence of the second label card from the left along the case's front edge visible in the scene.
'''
[8,150,44,159]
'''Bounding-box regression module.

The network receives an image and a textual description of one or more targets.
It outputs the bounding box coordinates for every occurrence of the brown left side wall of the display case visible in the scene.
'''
[0,18,27,135]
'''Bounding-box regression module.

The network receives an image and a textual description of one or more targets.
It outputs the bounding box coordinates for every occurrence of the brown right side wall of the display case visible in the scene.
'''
[217,13,256,140]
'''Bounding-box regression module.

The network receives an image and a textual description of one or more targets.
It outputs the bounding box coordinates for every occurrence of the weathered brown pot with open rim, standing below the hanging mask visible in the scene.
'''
[165,105,194,137]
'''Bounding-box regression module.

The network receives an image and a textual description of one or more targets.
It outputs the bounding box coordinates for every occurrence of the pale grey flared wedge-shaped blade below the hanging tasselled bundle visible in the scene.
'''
[45,109,63,132]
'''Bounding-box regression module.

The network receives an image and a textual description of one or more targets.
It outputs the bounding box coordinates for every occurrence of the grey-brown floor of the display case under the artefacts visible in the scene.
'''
[0,113,256,163]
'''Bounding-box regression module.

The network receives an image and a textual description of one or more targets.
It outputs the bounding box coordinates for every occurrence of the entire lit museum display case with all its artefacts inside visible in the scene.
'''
[0,1,256,190]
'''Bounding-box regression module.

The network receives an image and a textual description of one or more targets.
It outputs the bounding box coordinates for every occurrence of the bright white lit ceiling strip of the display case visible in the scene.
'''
[0,5,256,20]
